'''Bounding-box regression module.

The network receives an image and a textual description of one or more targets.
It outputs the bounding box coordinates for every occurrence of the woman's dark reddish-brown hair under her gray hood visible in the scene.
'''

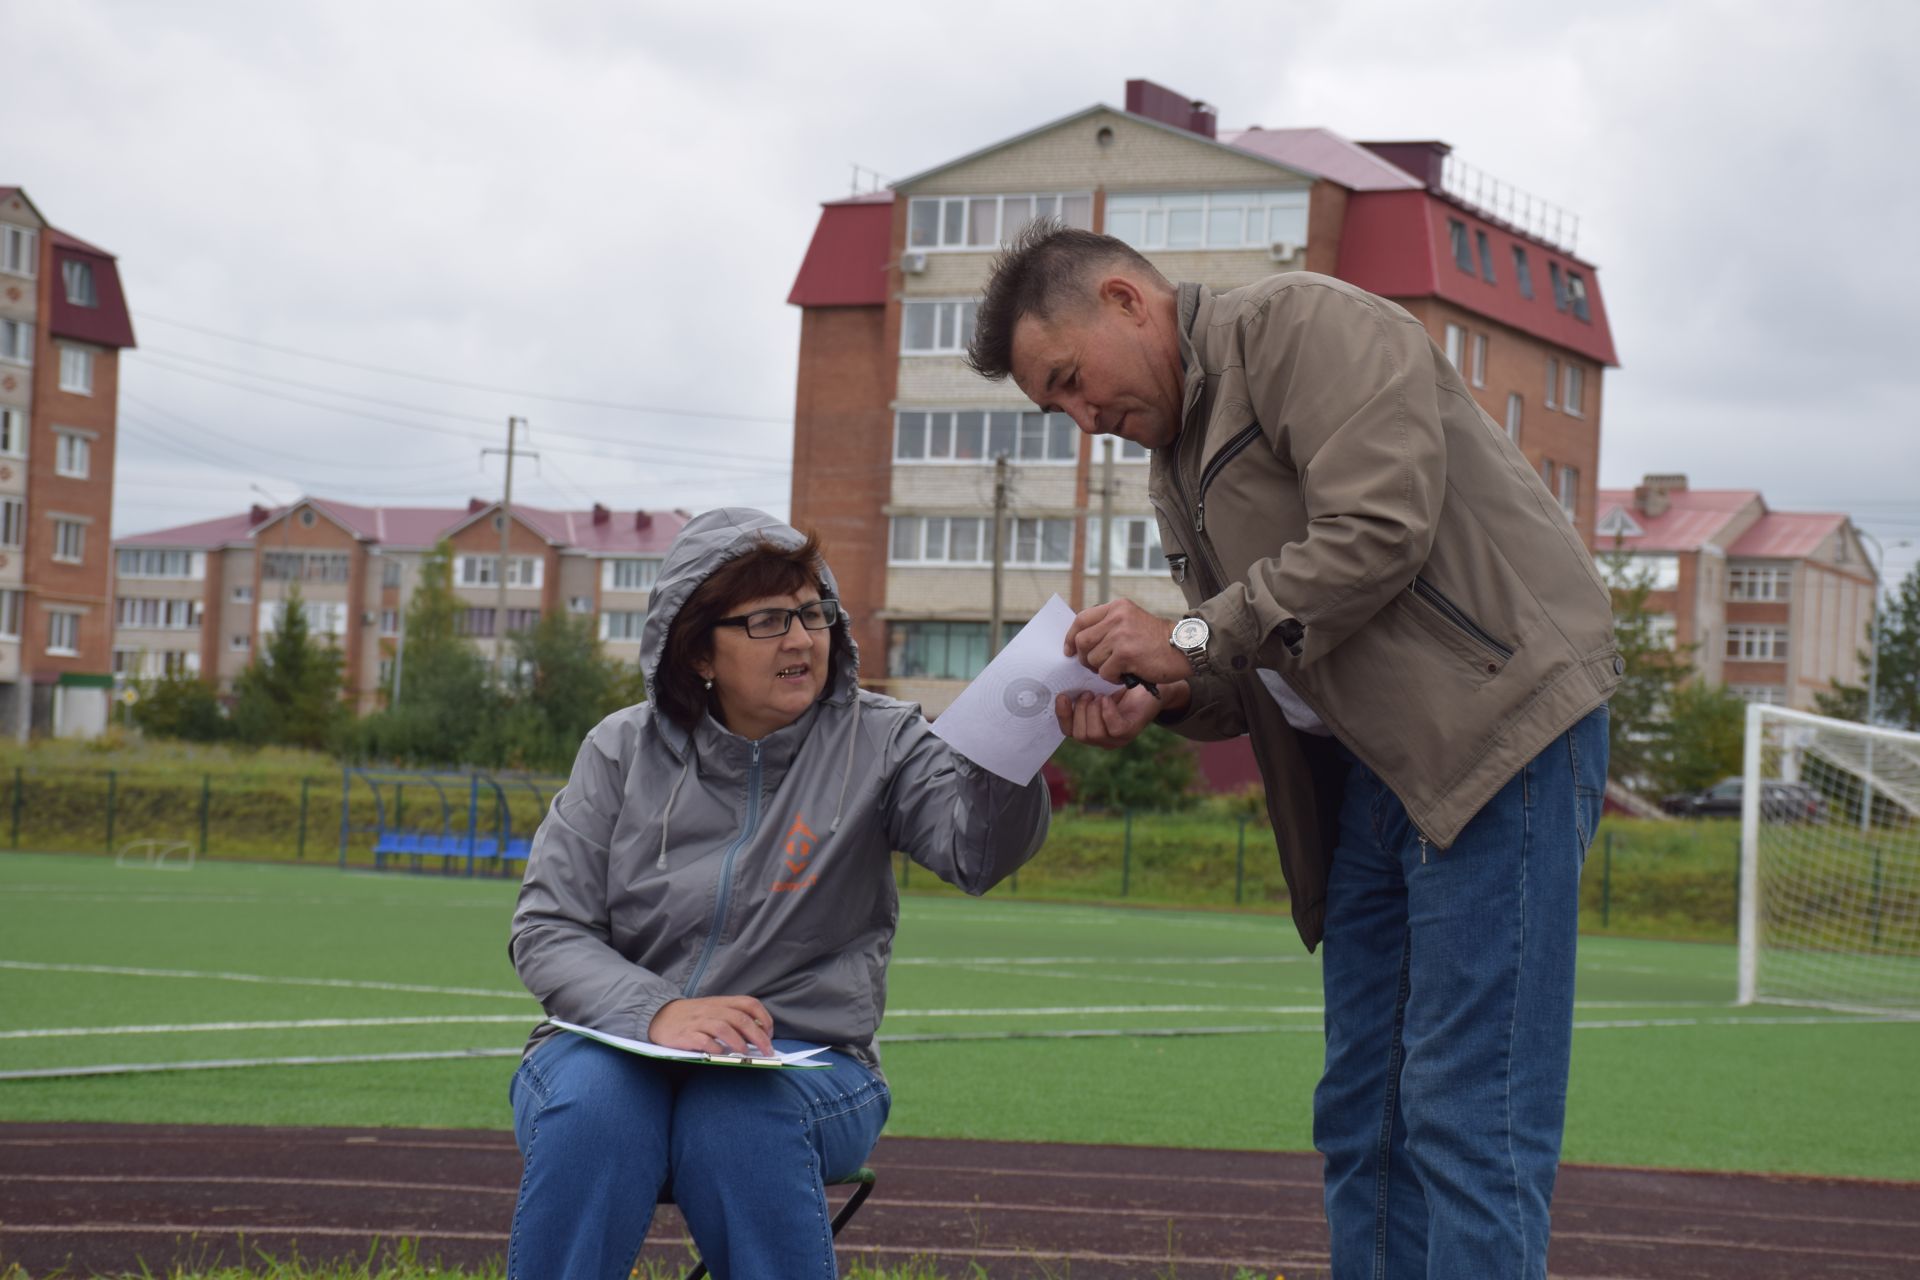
[647,530,847,729]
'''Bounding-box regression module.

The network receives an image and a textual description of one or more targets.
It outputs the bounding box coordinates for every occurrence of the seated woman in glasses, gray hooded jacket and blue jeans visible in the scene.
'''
[507,509,1048,1280]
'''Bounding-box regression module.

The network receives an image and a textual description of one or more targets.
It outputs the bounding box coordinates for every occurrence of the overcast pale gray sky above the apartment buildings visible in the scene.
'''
[0,0,1920,578]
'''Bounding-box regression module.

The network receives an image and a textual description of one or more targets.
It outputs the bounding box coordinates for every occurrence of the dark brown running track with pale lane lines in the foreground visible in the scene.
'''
[0,1125,1920,1280]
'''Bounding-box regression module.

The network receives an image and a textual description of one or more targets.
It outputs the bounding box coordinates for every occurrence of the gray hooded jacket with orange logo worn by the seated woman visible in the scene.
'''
[507,509,1048,1069]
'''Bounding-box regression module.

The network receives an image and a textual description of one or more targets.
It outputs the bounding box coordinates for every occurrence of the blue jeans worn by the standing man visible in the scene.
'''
[1313,706,1607,1280]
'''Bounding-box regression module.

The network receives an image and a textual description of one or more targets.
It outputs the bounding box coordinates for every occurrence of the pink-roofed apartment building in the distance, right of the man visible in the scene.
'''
[1592,476,1878,710]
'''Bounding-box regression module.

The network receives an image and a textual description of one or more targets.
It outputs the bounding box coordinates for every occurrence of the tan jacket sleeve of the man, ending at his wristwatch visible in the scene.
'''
[1194,284,1446,674]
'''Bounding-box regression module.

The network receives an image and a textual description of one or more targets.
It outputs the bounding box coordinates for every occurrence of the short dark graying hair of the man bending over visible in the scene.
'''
[966,219,1173,382]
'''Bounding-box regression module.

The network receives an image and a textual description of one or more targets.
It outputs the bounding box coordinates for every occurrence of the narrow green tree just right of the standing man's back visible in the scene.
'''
[1601,547,1693,791]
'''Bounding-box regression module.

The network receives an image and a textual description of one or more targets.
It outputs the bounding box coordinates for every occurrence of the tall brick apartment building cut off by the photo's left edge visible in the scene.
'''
[0,186,134,739]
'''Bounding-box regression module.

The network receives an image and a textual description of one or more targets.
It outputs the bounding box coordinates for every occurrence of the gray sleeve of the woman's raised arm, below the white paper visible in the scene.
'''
[883,712,1052,896]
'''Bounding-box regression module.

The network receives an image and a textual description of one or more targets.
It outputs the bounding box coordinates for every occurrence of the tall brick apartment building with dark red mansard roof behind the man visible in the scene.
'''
[789,81,1617,714]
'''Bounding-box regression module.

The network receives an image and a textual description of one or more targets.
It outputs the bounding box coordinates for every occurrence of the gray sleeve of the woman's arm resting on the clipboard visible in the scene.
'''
[507,723,680,1040]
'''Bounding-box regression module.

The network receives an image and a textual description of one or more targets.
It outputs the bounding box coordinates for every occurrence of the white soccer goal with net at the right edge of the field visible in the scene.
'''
[1740,704,1920,1017]
